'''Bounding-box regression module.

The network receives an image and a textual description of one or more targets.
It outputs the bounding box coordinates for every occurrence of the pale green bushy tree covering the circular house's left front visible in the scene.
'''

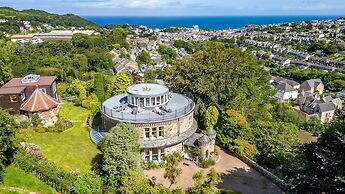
[99,123,140,176]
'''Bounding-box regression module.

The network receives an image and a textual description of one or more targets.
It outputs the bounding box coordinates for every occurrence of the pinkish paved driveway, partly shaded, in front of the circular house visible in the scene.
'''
[145,147,283,194]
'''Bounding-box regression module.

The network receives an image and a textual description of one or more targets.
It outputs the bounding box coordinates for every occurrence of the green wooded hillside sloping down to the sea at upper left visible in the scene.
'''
[0,7,96,33]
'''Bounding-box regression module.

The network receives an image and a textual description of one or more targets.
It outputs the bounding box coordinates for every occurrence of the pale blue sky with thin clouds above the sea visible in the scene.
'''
[0,0,345,16]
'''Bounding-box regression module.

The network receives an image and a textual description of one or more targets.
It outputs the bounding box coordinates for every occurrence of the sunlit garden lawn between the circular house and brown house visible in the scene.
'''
[28,102,100,173]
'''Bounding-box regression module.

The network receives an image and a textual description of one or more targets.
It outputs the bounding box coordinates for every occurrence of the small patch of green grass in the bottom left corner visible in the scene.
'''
[0,166,53,194]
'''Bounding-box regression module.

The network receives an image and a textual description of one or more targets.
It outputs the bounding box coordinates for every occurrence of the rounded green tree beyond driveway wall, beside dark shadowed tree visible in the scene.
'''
[251,121,301,177]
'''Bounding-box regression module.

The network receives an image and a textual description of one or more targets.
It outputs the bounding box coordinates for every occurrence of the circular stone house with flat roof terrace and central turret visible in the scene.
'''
[97,84,197,162]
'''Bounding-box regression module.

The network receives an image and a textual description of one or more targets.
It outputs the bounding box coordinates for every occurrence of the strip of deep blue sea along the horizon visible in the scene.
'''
[83,15,340,30]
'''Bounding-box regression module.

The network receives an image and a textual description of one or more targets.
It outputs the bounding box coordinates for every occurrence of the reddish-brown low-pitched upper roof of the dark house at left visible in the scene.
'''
[2,76,57,88]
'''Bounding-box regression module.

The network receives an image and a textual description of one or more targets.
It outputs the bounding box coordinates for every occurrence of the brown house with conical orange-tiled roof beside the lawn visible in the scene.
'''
[0,74,59,124]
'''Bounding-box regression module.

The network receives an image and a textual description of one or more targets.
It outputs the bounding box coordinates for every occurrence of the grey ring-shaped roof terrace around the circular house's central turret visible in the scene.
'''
[101,93,195,123]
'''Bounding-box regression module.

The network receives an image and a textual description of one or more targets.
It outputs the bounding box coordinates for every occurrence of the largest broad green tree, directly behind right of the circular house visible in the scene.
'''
[166,44,272,121]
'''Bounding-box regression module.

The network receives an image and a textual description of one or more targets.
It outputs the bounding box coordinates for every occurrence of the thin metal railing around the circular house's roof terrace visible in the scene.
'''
[100,99,195,123]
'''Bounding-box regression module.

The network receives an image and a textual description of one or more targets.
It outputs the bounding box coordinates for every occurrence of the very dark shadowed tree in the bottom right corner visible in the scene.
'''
[288,120,345,193]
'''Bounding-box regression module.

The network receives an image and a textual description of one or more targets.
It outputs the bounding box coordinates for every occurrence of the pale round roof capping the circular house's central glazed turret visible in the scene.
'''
[127,83,169,97]
